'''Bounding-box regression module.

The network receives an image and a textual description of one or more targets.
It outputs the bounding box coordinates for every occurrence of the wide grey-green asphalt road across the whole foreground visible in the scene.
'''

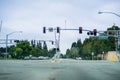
[0,60,120,80]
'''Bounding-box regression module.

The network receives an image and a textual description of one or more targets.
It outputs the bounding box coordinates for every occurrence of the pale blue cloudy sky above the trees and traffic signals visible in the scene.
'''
[0,0,120,54]
